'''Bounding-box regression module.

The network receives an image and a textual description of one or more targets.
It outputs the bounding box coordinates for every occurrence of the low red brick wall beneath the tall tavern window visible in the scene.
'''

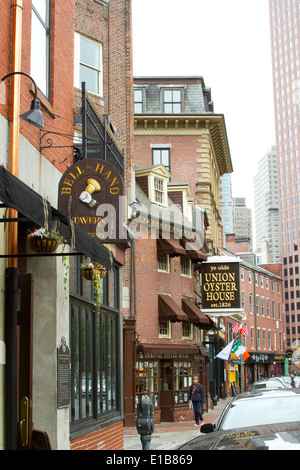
[71,423,123,450]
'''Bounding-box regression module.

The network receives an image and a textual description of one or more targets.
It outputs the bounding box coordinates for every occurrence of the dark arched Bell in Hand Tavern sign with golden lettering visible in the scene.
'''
[58,158,125,242]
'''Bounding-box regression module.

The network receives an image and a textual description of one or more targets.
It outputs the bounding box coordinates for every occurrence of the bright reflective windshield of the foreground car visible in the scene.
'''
[220,392,300,429]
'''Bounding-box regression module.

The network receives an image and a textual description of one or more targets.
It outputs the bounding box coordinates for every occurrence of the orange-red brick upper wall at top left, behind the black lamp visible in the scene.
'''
[0,0,74,172]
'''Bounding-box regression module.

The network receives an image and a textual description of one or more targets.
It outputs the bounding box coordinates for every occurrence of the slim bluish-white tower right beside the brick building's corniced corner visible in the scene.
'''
[220,173,233,247]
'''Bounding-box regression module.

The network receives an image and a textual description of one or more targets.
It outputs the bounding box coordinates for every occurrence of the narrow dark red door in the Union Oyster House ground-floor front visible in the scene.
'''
[160,361,174,422]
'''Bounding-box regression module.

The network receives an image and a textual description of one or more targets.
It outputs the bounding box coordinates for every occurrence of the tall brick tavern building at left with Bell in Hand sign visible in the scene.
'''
[0,0,133,450]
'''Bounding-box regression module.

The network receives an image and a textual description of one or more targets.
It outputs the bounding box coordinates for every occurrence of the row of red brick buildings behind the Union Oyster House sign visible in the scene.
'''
[225,234,286,389]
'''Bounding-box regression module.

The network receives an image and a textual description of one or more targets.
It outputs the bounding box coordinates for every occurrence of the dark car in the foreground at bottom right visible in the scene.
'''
[179,388,300,451]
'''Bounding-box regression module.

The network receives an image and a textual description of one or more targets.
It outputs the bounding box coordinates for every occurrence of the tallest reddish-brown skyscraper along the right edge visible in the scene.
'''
[269,0,300,347]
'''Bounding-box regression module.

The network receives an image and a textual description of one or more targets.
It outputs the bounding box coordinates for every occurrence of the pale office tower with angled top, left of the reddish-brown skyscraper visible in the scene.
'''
[254,146,280,263]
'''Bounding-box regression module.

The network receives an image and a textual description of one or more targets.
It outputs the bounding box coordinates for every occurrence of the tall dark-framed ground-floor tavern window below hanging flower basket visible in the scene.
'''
[70,256,120,429]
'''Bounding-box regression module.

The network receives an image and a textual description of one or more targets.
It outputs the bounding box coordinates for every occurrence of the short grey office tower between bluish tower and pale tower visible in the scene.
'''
[232,197,252,251]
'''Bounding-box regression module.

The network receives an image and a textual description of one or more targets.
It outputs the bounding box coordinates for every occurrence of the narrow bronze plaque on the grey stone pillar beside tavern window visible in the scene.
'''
[57,338,71,408]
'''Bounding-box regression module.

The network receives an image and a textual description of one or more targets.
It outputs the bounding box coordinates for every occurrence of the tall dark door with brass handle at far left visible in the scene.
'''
[18,274,33,450]
